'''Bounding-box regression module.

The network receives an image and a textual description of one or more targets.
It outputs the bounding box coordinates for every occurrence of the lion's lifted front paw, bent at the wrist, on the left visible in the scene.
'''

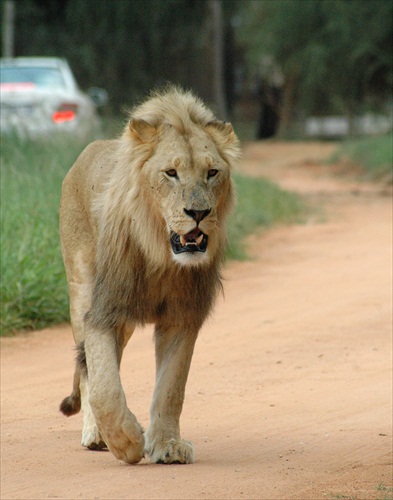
[101,414,145,464]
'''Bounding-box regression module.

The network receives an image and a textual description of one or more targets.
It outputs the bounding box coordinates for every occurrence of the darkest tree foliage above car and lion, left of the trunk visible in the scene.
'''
[7,0,237,111]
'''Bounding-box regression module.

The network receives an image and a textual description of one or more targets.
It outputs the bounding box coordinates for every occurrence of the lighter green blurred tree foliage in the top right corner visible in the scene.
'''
[241,0,393,132]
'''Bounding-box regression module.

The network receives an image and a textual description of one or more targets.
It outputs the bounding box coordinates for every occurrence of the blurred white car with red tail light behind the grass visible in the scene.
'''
[0,57,107,139]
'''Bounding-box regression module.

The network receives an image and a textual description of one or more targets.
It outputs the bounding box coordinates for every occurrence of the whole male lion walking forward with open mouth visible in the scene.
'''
[60,86,240,464]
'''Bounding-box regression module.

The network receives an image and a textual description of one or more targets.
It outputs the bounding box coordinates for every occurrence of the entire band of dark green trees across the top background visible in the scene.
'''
[0,0,393,138]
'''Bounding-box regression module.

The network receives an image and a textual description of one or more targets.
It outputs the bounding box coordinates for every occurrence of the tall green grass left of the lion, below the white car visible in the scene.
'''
[0,137,83,334]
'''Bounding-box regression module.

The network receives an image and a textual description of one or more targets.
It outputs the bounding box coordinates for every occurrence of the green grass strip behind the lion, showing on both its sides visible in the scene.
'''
[0,137,302,335]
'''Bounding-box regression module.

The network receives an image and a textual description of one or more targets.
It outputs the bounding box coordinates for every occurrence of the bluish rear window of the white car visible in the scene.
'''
[0,66,65,90]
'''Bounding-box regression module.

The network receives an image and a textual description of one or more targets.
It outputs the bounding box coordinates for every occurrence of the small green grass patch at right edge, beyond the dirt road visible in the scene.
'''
[330,133,393,183]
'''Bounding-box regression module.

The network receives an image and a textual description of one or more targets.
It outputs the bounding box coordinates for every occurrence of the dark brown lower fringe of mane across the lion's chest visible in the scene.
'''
[89,243,223,334]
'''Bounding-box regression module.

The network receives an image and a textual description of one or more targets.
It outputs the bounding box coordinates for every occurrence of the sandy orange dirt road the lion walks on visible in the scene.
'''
[1,143,393,500]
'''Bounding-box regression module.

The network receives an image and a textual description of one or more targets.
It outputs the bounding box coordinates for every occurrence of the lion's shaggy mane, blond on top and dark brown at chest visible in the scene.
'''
[87,88,239,332]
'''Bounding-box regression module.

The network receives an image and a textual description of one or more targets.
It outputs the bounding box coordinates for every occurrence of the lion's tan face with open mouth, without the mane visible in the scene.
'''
[141,126,233,265]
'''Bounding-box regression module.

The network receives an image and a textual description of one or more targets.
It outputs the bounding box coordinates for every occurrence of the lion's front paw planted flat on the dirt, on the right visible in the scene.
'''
[146,439,194,464]
